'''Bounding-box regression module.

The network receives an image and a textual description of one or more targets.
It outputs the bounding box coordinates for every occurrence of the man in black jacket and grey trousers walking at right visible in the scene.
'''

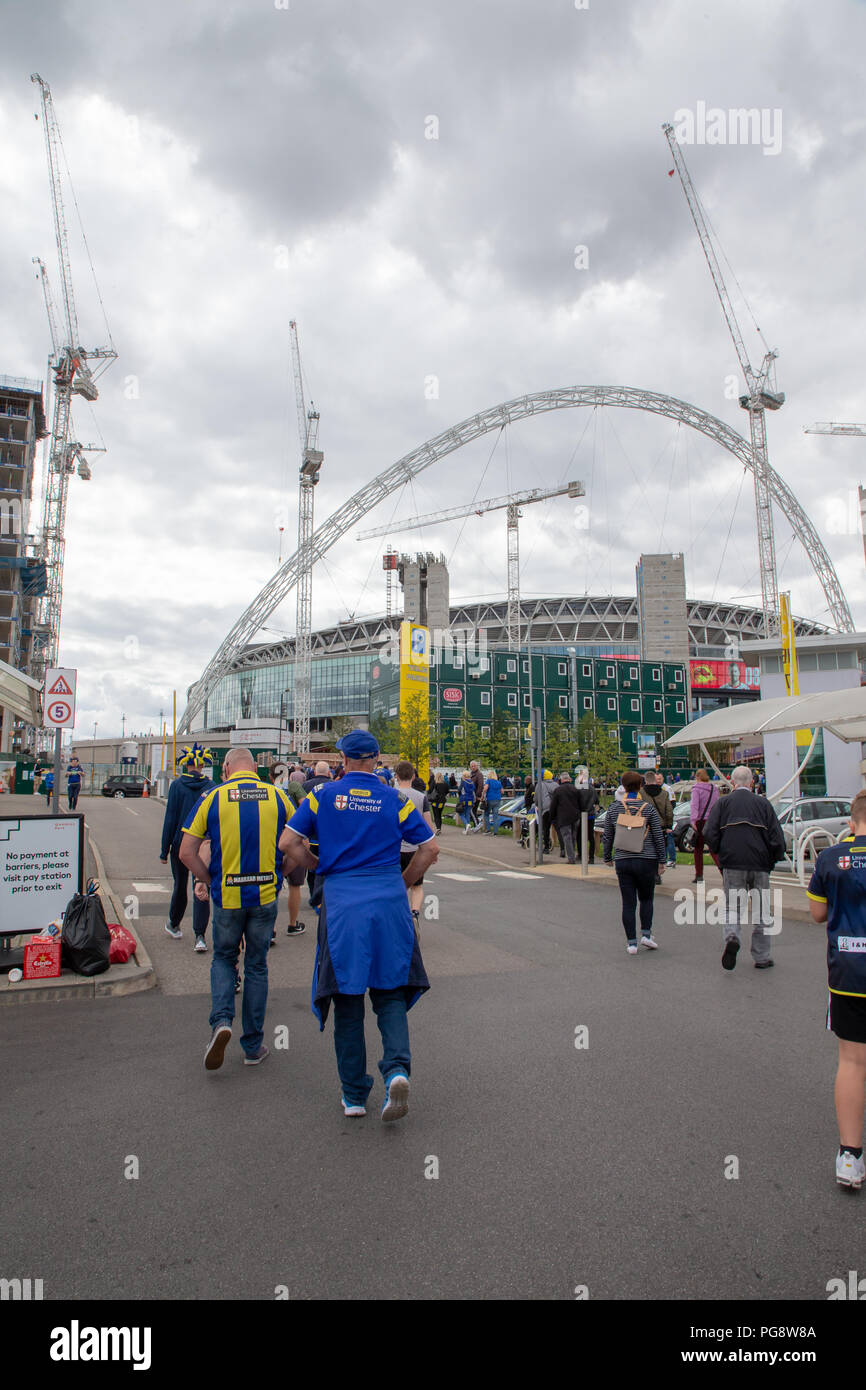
[703,767,785,970]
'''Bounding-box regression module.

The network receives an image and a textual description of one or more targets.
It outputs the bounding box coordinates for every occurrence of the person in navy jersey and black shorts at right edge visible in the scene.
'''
[808,791,866,1191]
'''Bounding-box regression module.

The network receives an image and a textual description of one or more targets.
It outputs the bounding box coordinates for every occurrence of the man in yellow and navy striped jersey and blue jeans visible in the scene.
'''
[181,748,295,1072]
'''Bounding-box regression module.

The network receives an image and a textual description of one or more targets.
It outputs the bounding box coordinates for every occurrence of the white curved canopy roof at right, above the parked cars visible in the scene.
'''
[663,685,866,748]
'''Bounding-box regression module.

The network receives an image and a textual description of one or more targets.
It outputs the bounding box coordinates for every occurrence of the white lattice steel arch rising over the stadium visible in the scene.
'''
[179,386,853,733]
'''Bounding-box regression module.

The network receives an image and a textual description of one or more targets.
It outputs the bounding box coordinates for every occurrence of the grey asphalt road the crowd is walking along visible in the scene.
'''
[0,801,866,1300]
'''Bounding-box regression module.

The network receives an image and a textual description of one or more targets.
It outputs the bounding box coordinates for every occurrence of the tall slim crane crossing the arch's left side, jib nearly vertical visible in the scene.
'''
[289,318,325,758]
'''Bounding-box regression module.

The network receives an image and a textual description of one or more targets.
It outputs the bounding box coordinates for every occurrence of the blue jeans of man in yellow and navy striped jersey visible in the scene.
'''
[210,902,277,1056]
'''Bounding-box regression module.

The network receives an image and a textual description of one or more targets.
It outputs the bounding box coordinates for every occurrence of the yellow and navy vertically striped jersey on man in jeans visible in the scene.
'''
[183,773,295,908]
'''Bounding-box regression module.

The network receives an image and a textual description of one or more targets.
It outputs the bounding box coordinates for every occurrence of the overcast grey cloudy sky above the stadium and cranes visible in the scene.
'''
[0,0,866,737]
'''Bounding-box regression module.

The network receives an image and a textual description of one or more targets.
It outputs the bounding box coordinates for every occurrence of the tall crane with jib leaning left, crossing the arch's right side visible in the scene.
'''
[662,124,785,637]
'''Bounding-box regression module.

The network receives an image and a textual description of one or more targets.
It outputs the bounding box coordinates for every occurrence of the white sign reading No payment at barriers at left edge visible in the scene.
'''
[0,816,85,935]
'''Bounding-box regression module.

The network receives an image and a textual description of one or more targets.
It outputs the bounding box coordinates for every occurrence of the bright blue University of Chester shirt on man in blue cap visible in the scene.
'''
[291,773,434,877]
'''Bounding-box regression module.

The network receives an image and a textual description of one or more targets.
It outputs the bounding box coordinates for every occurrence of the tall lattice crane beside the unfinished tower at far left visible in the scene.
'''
[31,72,117,678]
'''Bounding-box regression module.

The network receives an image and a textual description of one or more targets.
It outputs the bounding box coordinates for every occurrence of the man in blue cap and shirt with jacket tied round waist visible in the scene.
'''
[279,728,439,1122]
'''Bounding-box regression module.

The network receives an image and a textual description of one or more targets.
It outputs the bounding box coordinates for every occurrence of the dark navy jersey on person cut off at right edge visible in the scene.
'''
[808,834,866,998]
